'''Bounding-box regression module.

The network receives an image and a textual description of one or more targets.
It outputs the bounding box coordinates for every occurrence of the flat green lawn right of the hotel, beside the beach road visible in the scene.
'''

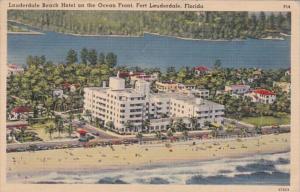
[241,115,291,126]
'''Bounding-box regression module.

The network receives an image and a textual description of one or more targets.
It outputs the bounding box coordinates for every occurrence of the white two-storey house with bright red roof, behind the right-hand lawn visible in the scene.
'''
[247,89,276,104]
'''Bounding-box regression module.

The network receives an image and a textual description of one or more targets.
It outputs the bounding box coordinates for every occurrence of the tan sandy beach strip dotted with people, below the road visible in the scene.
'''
[7,133,290,174]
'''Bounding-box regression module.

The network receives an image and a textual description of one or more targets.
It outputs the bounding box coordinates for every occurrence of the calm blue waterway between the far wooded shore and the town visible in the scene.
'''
[8,32,290,70]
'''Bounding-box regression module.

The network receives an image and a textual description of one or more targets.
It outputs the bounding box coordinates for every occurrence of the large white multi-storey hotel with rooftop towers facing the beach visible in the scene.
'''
[84,77,224,132]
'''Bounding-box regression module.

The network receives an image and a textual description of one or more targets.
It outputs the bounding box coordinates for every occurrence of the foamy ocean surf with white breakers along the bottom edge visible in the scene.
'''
[7,152,290,185]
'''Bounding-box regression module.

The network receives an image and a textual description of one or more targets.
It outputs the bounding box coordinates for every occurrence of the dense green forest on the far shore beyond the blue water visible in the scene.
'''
[8,10,291,39]
